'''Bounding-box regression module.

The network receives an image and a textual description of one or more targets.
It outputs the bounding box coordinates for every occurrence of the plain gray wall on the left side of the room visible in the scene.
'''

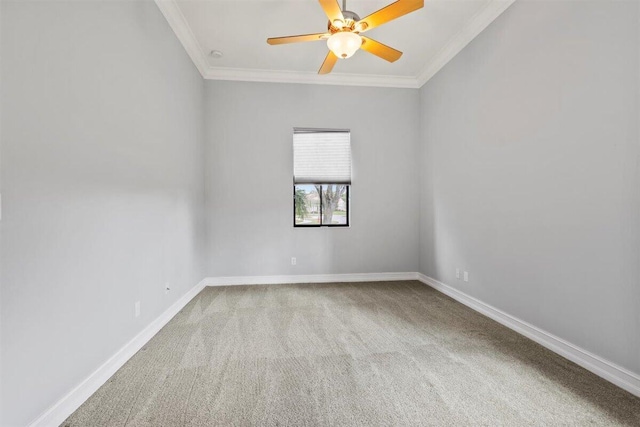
[0,1,204,426]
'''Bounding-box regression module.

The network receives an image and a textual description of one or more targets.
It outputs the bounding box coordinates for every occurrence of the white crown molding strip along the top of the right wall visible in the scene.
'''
[416,0,516,87]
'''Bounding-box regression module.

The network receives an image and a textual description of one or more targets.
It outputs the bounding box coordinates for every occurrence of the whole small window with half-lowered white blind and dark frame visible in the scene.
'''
[293,128,351,227]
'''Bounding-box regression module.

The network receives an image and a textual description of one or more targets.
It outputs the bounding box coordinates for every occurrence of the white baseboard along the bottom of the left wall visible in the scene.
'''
[29,280,205,427]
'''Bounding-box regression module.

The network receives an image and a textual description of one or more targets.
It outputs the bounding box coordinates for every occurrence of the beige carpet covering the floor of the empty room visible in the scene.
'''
[63,282,640,427]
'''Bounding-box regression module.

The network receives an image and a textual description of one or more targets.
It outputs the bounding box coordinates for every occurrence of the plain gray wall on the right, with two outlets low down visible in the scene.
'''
[420,1,640,378]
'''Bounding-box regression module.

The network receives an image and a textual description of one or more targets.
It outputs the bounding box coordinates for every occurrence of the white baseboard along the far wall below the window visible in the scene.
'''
[204,272,418,286]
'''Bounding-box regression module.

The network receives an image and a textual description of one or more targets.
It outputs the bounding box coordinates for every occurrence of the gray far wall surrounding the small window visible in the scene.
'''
[205,81,419,276]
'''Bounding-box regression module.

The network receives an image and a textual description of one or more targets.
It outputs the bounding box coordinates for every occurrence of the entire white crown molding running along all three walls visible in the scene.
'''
[155,0,515,89]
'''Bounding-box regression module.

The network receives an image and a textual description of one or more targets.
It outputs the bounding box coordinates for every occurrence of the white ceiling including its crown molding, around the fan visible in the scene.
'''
[156,0,514,87]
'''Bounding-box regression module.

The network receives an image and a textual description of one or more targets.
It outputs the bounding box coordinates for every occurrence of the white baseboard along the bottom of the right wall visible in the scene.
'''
[417,273,640,397]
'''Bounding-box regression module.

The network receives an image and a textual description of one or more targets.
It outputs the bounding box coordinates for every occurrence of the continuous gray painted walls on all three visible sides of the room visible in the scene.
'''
[0,1,640,426]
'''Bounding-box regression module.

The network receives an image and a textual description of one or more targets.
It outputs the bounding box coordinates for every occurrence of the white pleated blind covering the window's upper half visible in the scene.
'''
[293,128,351,184]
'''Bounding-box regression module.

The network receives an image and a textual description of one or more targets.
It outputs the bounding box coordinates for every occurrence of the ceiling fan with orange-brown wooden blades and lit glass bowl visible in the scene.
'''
[267,0,424,74]
